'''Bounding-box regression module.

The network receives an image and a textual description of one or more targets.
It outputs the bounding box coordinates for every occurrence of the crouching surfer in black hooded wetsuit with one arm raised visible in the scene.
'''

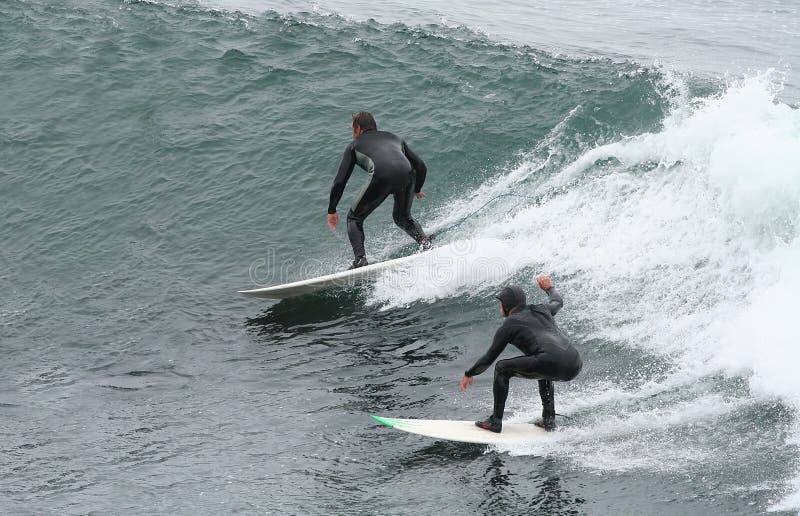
[461,276,583,432]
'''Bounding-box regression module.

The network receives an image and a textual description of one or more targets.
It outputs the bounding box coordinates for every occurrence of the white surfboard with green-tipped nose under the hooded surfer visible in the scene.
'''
[372,416,553,444]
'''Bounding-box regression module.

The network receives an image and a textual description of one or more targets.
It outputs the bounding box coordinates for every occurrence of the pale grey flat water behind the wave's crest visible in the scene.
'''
[208,0,800,101]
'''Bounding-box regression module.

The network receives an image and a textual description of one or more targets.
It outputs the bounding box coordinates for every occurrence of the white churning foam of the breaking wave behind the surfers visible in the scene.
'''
[372,75,800,507]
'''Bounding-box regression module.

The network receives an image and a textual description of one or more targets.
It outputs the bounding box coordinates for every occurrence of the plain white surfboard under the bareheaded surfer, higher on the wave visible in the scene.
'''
[239,253,424,299]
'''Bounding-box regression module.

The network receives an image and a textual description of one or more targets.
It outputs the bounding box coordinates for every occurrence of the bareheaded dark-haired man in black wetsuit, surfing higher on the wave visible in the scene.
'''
[328,111,432,269]
